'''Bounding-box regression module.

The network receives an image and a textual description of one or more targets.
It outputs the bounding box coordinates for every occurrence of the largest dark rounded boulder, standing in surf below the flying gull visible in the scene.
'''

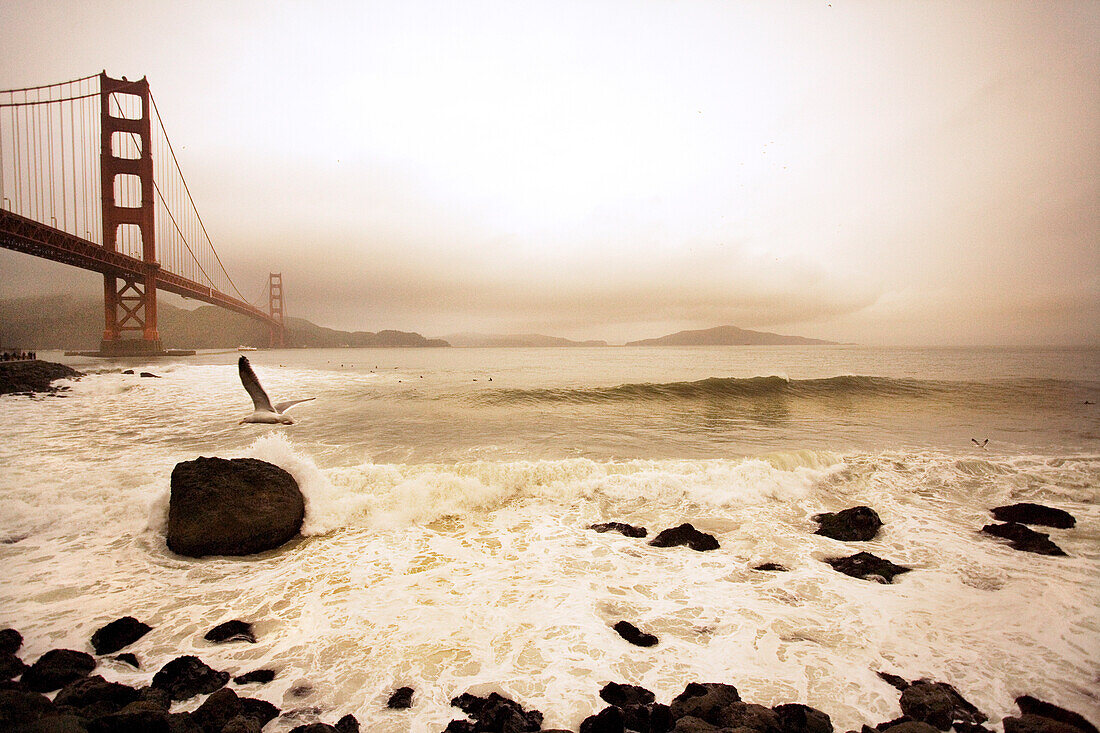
[167,458,306,557]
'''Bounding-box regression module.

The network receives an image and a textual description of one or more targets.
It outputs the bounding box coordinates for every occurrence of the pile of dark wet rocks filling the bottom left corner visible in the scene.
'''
[0,616,374,733]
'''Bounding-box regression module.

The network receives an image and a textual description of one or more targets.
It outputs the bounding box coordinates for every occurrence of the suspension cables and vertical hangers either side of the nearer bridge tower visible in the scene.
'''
[0,75,259,307]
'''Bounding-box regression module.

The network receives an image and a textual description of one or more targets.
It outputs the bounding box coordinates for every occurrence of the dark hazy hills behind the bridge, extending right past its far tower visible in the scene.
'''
[0,295,450,350]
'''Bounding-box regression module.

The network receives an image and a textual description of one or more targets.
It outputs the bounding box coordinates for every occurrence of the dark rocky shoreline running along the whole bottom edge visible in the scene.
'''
[0,616,1098,733]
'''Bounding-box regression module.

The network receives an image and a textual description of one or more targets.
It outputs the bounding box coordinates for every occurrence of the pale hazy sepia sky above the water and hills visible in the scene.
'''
[0,0,1100,344]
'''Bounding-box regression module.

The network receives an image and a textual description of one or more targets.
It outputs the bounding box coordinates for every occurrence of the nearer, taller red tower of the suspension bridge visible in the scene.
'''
[99,73,163,354]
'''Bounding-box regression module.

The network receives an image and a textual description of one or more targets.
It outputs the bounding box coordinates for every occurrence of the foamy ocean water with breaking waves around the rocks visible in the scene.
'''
[0,347,1100,732]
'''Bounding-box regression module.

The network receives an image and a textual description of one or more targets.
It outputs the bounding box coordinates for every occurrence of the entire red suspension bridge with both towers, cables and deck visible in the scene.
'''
[0,72,286,355]
